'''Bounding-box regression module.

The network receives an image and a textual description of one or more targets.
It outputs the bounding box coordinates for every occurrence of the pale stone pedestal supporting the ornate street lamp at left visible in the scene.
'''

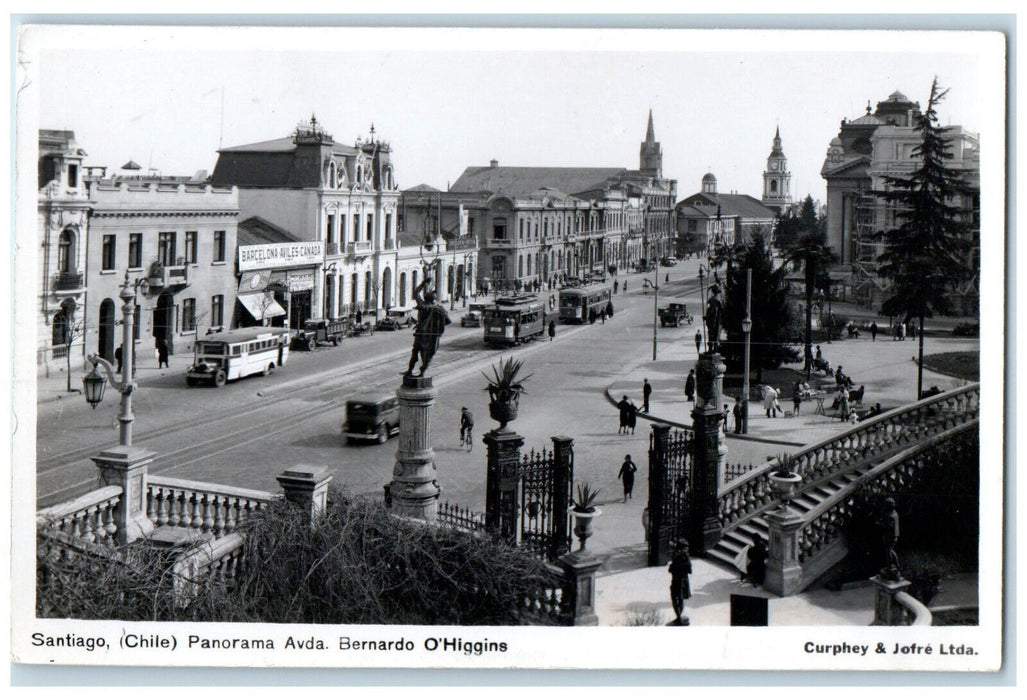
[89,445,157,544]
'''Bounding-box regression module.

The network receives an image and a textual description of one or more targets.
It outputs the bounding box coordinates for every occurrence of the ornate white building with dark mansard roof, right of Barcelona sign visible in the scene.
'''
[212,117,476,316]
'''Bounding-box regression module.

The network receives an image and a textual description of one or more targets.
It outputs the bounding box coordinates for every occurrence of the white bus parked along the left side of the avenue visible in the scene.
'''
[186,327,289,387]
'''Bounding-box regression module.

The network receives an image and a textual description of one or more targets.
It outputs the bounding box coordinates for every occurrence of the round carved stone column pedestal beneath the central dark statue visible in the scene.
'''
[388,376,442,521]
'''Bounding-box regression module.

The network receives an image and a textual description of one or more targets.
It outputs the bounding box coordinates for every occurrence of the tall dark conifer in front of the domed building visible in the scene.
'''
[875,78,969,398]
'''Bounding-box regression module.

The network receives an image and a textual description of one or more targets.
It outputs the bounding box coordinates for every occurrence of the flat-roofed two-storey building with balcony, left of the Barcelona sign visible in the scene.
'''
[85,168,239,359]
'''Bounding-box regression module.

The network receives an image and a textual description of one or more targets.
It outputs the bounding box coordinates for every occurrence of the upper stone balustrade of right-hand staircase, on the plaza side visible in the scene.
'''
[718,384,981,529]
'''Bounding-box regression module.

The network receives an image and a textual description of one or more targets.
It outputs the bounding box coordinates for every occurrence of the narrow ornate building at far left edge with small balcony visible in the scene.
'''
[36,129,89,375]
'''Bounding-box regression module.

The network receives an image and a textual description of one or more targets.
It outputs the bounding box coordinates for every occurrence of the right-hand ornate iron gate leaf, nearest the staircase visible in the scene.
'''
[648,425,693,567]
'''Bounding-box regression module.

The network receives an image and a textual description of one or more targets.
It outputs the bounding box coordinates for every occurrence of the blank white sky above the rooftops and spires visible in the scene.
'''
[20,27,1000,200]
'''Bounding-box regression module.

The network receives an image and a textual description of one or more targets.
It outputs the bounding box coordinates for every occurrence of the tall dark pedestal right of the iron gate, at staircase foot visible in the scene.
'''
[688,352,727,556]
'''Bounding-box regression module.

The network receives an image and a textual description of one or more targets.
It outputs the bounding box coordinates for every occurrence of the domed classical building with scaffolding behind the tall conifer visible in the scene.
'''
[821,91,980,314]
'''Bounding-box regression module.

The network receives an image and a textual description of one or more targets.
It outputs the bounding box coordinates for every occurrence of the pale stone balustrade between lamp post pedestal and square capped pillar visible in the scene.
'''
[146,475,280,538]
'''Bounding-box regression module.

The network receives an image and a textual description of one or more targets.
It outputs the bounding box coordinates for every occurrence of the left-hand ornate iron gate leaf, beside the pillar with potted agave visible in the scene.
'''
[520,437,574,561]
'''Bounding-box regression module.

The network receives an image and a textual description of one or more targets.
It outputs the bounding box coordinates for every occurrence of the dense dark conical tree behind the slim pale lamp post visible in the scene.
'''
[721,236,799,371]
